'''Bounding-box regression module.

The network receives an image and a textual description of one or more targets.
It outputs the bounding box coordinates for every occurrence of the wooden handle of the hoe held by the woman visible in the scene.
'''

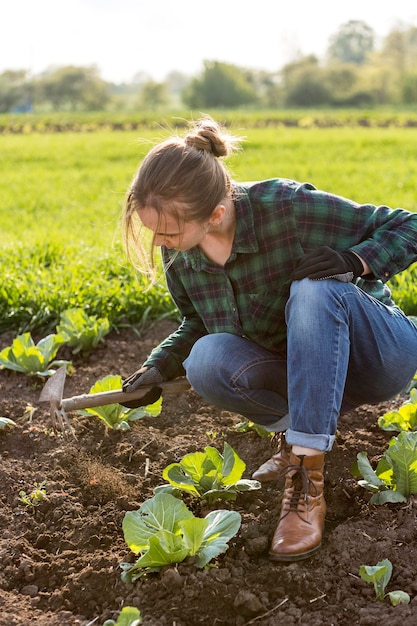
[60,378,190,411]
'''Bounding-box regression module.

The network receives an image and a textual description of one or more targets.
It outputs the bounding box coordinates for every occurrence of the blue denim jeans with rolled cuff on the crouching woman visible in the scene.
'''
[184,278,417,452]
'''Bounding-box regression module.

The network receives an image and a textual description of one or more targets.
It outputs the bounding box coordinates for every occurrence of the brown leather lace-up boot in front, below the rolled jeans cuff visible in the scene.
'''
[269,452,326,561]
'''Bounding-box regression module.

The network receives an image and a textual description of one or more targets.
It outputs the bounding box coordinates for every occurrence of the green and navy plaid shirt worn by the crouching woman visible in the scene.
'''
[146,178,417,378]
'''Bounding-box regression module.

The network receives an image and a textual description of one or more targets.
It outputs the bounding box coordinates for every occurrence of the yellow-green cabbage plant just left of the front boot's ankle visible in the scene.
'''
[155,443,261,505]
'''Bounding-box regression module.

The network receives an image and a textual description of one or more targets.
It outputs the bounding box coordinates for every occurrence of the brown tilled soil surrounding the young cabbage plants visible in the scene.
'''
[0,322,417,626]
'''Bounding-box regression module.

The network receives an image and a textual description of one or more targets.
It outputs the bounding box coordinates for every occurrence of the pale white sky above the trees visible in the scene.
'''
[0,0,417,83]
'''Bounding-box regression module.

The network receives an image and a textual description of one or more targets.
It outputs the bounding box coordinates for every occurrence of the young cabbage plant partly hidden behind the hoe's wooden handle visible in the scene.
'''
[78,375,162,430]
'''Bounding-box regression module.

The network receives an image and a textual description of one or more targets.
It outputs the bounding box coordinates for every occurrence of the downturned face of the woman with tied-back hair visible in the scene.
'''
[138,208,210,252]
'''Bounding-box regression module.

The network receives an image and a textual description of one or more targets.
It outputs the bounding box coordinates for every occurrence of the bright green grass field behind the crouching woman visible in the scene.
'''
[0,120,417,333]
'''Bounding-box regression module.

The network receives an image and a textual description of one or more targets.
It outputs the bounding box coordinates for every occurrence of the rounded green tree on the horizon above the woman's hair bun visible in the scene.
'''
[182,61,257,108]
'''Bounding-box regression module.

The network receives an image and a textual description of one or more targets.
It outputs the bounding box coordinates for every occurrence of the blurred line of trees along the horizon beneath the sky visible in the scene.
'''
[0,20,417,113]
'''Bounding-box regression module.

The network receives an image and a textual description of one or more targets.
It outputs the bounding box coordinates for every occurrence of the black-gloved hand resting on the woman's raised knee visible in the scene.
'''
[292,246,364,282]
